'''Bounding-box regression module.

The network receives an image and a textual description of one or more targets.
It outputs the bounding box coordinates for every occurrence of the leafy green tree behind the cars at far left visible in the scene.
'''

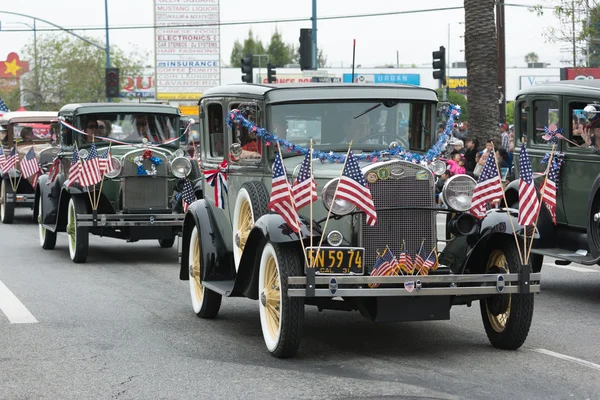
[22,34,143,110]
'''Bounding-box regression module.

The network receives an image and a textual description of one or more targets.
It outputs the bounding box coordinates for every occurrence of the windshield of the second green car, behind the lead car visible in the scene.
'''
[78,113,179,144]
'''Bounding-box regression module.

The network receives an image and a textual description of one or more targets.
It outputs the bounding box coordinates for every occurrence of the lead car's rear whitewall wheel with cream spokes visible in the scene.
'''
[188,227,221,318]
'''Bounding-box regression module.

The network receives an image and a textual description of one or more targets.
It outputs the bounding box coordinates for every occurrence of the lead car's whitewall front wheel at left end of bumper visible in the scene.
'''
[258,243,304,358]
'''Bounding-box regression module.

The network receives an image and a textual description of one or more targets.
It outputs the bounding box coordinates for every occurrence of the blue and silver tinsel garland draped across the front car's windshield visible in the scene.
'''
[227,104,460,164]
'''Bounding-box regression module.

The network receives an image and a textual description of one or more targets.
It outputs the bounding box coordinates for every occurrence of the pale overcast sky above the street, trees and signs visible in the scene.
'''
[0,0,569,67]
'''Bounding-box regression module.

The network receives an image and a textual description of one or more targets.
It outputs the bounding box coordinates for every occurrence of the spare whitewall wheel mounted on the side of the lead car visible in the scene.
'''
[232,182,269,271]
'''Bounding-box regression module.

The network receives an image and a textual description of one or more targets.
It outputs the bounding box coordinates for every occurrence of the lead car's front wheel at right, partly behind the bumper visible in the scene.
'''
[479,238,533,350]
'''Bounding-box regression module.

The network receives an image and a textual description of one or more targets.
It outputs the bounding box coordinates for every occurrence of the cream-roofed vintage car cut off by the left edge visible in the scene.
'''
[0,111,58,224]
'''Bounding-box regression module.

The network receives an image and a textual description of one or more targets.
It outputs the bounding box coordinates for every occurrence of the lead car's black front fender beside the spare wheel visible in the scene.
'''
[233,214,321,300]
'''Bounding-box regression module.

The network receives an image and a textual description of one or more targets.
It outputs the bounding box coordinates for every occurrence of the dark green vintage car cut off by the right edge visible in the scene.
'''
[506,80,600,271]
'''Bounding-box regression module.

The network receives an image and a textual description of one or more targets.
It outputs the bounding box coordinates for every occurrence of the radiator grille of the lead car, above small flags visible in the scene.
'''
[361,161,437,271]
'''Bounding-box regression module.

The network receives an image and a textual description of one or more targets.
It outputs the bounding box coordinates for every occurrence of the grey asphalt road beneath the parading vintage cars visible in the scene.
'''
[0,210,600,400]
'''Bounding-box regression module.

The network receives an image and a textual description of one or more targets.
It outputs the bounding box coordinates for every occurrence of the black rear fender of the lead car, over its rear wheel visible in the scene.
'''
[179,199,235,281]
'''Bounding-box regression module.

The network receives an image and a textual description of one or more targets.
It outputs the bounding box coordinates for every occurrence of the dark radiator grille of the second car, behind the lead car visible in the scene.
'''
[123,176,169,211]
